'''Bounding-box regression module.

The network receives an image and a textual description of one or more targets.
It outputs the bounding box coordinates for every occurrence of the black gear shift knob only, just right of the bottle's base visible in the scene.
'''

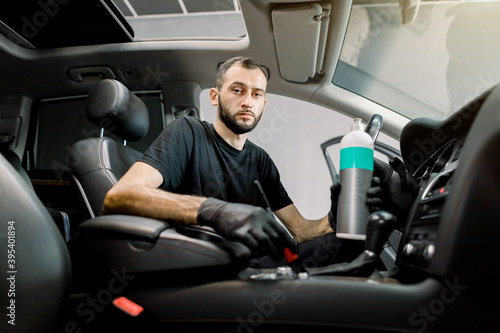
[365,211,397,255]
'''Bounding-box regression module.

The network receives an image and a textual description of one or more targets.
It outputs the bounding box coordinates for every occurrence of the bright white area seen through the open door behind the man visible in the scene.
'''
[200,90,399,219]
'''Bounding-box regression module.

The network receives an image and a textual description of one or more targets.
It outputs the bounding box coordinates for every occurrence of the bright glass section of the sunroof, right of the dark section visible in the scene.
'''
[113,0,246,41]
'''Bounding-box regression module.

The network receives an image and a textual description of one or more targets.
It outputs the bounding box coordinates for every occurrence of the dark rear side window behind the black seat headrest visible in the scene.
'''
[26,92,163,178]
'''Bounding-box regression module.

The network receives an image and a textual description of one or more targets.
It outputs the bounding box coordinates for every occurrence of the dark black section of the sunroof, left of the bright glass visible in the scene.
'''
[0,0,133,49]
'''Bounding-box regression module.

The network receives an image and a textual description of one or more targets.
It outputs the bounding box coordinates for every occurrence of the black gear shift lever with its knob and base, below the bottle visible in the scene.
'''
[306,211,397,276]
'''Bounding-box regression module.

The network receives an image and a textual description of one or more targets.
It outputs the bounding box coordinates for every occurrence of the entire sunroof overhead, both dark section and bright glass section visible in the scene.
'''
[0,0,247,49]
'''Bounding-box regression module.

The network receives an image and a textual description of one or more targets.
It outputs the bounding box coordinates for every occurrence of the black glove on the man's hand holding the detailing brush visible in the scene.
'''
[198,198,299,260]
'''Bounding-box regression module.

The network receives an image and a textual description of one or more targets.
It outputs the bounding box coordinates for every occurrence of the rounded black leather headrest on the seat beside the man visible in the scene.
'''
[87,79,149,141]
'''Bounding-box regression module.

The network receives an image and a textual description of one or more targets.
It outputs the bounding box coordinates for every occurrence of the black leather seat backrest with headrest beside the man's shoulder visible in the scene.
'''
[68,79,149,220]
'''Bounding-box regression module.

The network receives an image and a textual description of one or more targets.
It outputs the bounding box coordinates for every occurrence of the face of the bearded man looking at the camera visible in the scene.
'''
[211,65,267,134]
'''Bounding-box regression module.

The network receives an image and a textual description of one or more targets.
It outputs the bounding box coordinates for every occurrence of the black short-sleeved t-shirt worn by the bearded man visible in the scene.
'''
[140,117,292,210]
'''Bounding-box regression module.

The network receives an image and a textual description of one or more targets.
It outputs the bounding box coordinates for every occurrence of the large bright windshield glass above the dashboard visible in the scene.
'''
[333,0,500,119]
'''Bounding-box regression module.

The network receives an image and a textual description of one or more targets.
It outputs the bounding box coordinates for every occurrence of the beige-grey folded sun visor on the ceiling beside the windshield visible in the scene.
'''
[272,2,331,82]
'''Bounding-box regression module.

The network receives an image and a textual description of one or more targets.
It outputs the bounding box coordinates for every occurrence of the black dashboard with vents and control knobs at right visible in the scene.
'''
[396,85,500,281]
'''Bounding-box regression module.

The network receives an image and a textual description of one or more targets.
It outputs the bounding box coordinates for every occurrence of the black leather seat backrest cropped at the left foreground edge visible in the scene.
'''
[0,154,71,332]
